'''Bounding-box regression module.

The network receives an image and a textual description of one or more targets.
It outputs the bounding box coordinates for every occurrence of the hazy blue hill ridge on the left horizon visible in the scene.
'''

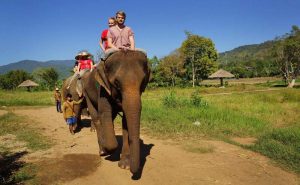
[0,60,75,79]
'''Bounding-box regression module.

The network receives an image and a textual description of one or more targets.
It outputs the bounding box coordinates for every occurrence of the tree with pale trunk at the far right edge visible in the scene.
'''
[273,26,300,88]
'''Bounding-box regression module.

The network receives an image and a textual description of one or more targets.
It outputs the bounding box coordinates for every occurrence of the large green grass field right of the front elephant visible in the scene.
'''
[142,86,300,173]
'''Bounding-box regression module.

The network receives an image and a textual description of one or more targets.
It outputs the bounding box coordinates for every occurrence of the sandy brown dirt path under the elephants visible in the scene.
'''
[15,107,299,185]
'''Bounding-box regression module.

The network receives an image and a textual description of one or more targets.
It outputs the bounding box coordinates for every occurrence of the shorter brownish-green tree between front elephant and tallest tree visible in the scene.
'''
[158,50,185,86]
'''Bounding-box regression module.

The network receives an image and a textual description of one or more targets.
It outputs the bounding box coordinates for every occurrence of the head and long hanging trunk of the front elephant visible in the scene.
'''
[95,50,150,173]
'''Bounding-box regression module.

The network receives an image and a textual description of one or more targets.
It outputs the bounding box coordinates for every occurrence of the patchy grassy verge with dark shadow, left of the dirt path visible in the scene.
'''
[0,112,52,185]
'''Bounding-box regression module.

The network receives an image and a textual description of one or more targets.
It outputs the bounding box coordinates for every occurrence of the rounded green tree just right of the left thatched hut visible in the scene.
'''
[34,68,59,90]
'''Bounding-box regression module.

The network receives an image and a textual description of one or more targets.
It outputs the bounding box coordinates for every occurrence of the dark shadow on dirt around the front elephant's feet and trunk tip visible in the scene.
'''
[104,135,154,180]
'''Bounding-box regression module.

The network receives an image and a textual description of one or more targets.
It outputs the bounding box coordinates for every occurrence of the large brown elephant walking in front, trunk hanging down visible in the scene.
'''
[82,50,150,174]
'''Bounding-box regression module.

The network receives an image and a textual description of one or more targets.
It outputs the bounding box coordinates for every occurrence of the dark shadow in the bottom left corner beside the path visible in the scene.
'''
[0,151,29,185]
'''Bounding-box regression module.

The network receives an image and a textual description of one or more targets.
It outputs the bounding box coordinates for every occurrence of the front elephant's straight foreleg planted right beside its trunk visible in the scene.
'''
[118,115,130,169]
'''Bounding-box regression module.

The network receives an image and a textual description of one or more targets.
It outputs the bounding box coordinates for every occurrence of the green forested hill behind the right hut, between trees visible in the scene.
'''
[218,40,278,77]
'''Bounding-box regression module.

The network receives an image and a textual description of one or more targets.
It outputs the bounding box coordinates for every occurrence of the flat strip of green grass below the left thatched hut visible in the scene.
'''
[0,90,54,106]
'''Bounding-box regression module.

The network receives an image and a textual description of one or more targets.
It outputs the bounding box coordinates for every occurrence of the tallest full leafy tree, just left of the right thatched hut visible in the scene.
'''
[180,32,218,87]
